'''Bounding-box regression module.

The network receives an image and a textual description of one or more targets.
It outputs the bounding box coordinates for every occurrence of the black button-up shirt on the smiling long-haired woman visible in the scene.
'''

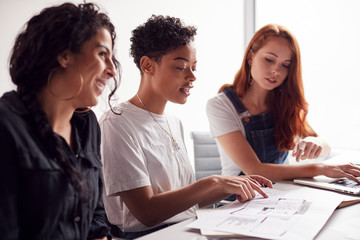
[0,91,108,240]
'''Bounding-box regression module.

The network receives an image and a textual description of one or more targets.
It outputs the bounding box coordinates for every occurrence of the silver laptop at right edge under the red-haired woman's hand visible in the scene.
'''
[294,176,360,195]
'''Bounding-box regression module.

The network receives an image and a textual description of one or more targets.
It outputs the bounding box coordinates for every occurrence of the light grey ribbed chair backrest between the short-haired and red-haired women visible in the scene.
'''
[191,132,221,180]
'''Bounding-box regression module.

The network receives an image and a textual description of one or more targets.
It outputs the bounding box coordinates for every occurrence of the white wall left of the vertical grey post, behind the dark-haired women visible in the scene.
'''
[0,0,244,168]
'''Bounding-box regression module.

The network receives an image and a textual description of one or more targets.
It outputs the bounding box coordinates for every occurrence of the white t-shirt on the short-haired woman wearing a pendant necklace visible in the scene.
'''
[100,101,197,232]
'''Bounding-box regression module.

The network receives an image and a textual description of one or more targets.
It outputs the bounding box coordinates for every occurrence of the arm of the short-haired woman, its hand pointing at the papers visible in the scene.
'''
[119,175,272,226]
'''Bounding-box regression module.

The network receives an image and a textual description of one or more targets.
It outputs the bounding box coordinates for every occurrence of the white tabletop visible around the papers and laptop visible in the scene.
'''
[138,181,360,240]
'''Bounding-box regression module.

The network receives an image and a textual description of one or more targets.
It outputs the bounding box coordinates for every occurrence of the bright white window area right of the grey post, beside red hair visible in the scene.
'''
[255,0,360,149]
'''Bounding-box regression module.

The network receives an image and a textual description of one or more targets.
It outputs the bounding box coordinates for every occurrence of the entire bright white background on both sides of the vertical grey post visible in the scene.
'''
[0,0,360,166]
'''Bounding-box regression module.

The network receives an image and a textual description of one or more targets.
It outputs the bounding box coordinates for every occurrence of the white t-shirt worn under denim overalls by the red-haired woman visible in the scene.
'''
[206,92,250,176]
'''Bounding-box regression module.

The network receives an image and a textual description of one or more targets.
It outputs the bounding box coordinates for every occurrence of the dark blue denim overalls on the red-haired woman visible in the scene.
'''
[223,87,288,200]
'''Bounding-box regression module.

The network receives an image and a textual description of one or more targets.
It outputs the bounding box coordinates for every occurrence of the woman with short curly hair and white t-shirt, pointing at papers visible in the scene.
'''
[100,16,271,239]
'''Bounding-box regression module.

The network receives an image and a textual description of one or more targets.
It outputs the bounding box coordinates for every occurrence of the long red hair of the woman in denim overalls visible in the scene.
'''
[219,24,316,151]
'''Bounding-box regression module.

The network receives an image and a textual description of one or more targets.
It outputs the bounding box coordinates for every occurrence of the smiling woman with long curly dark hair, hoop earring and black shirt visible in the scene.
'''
[0,3,117,240]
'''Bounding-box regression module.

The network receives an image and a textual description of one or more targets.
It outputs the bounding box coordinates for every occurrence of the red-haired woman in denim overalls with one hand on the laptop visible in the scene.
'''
[207,24,360,188]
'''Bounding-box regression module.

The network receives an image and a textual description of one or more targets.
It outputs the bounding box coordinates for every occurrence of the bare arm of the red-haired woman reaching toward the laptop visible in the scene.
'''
[217,131,360,181]
